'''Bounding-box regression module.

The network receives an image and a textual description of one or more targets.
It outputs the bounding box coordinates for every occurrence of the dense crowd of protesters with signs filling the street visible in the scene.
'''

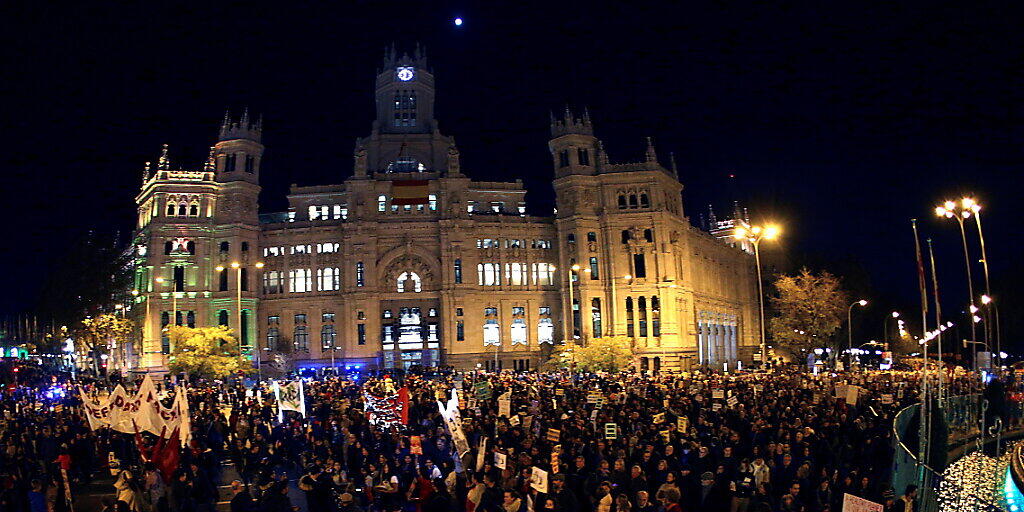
[0,370,1007,512]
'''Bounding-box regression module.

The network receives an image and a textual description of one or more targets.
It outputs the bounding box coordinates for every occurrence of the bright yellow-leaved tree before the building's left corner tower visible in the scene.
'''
[167,326,253,379]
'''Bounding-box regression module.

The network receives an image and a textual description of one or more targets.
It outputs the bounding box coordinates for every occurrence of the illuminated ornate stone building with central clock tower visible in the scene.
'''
[133,51,758,370]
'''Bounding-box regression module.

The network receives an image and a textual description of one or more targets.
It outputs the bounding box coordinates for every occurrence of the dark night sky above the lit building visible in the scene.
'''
[0,2,1024,348]
